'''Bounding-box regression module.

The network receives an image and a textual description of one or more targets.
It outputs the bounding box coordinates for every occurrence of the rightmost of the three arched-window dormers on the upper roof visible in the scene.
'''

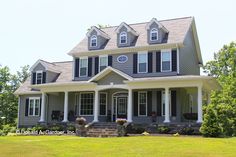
[146,18,169,44]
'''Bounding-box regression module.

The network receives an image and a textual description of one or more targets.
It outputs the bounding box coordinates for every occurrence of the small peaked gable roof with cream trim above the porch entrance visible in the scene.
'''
[88,66,133,82]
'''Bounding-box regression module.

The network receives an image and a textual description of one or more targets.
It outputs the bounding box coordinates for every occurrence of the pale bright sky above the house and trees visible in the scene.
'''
[0,0,236,72]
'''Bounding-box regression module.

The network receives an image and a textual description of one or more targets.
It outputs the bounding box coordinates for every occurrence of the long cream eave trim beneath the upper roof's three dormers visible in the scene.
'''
[68,42,184,57]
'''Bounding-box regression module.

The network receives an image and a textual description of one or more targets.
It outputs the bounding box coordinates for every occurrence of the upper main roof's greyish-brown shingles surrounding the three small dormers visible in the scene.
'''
[68,17,193,56]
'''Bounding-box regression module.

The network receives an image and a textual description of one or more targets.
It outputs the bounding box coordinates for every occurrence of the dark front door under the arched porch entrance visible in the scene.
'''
[117,97,127,118]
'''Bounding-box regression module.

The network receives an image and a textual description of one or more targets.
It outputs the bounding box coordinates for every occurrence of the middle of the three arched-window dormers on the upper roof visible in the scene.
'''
[116,22,138,47]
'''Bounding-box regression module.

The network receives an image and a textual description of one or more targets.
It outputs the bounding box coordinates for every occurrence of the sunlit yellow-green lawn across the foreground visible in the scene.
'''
[0,136,236,157]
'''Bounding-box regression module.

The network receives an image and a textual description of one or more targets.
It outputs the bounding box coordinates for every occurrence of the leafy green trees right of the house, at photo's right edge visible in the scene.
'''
[201,42,236,136]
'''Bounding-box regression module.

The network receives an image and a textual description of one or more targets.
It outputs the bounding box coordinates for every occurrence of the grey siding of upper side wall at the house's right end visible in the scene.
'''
[179,28,200,75]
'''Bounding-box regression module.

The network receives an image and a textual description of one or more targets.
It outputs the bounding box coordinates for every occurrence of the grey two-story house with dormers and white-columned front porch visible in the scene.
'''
[15,17,219,126]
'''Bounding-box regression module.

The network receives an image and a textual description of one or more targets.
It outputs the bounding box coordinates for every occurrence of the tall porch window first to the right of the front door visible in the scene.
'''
[138,92,147,116]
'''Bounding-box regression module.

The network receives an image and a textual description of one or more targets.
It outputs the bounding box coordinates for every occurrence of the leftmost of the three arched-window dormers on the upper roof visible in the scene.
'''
[87,26,110,50]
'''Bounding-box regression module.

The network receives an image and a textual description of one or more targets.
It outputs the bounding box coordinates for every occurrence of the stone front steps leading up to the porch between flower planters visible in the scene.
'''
[87,122,118,137]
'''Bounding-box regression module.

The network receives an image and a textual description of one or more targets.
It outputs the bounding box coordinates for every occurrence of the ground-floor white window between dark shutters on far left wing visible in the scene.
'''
[28,97,40,116]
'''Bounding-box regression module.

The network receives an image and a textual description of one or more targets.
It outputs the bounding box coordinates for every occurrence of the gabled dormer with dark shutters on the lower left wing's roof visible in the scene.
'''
[30,60,61,85]
